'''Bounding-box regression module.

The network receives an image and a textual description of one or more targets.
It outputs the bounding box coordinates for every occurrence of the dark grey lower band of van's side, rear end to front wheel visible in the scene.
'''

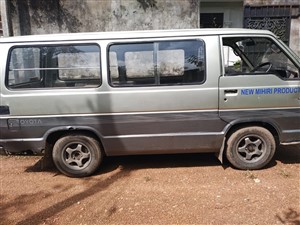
[1,111,224,155]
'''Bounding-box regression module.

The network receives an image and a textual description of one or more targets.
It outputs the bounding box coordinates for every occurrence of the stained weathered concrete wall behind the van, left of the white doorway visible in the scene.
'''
[5,0,199,36]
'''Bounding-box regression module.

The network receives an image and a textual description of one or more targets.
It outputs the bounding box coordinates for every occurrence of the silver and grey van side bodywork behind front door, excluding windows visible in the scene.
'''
[0,36,227,155]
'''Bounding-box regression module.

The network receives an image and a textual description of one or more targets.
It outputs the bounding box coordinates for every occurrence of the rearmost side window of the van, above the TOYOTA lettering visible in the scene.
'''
[6,45,100,89]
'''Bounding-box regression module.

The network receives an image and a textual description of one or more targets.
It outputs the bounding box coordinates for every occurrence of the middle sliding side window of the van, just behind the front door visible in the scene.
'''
[109,40,205,86]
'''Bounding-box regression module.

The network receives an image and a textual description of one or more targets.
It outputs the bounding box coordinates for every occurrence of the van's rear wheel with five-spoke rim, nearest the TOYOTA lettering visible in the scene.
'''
[52,134,103,177]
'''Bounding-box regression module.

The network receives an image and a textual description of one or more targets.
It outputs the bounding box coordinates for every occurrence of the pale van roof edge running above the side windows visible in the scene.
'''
[0,28,274,43]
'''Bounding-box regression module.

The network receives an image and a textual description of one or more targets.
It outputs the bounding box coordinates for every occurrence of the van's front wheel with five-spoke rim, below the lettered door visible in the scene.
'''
[226,126,276,170]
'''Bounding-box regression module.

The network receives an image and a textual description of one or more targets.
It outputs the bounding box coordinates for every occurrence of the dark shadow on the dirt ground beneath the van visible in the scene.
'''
[26,145,300,175]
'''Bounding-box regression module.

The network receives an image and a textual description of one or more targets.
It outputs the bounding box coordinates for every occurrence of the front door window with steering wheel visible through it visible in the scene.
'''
[223,37,299,79]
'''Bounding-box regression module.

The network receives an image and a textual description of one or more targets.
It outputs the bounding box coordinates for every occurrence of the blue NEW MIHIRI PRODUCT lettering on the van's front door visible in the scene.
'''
[241,87,300,95]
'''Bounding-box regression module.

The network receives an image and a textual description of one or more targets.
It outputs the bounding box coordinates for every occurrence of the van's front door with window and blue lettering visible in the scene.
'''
[219,36,300,144]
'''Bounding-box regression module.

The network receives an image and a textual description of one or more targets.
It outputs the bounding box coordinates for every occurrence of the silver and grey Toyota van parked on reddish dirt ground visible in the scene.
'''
[0,29,300,177]
